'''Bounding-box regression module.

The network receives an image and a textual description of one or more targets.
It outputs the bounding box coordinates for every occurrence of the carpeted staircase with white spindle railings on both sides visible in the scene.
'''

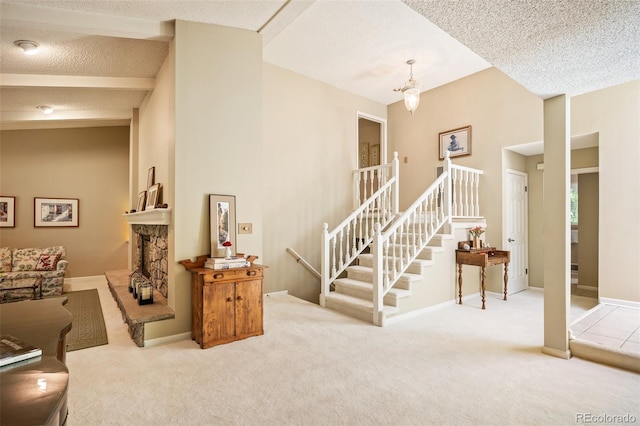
[320,153,484,326]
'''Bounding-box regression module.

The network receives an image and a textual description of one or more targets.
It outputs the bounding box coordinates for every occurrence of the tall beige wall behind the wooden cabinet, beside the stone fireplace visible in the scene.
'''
[138,21,268,339]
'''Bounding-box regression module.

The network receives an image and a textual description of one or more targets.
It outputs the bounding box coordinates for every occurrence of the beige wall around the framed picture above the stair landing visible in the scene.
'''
[388,68,542,291]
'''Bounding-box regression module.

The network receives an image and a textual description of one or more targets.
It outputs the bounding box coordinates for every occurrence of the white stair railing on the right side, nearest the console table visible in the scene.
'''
[371,152,482,326]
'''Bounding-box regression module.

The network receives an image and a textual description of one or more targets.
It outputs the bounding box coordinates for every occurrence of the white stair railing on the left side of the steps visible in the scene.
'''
[320,152,399,306]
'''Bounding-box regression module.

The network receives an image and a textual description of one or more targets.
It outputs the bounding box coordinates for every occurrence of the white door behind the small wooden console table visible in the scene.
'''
[502,170,529,294]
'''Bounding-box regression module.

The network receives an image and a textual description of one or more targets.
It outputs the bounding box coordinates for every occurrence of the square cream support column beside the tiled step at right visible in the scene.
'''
[542,95,571,359]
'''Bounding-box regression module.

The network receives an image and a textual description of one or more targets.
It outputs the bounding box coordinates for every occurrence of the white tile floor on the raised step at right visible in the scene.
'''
[571,304,640,353]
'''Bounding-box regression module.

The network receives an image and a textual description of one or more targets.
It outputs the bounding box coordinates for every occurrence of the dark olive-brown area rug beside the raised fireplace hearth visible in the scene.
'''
[63,288,108,352]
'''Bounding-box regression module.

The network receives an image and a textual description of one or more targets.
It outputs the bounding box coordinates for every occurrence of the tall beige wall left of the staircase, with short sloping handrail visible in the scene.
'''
[262,63,387,303]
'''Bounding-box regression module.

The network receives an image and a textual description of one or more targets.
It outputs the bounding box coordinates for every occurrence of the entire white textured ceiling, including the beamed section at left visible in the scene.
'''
[0,0,640,151]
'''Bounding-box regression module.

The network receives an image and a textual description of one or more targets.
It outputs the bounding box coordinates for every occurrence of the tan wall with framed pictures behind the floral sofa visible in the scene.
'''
[0,127,130,278]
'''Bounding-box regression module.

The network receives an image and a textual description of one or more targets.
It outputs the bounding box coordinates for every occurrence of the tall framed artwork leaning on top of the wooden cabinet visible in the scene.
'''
[209,194,236,257]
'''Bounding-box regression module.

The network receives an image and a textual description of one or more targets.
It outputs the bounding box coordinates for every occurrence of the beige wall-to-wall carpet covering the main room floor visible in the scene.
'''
[67,282,640,426]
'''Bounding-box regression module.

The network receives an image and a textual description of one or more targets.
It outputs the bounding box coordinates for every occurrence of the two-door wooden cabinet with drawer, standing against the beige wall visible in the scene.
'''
[180,256,265,349]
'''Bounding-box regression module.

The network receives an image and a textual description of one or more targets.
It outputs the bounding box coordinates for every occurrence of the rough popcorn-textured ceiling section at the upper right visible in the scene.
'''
[403,0,640,98]
